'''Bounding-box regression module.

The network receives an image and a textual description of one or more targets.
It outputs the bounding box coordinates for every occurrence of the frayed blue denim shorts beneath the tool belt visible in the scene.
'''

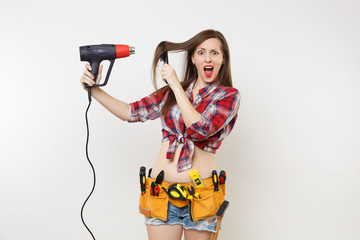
[145,202,217,233]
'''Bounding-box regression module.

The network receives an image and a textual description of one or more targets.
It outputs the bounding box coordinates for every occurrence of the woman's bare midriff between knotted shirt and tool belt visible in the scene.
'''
[151,141,216,183]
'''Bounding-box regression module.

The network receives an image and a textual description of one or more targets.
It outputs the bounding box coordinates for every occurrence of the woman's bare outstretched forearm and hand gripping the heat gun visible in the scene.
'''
[80,64,131,121]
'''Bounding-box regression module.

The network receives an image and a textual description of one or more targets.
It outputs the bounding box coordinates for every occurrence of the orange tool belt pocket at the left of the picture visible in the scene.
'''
[139,193,169,221]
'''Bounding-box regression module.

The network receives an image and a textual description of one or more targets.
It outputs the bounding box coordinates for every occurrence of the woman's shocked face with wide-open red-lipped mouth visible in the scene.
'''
[192,38,224,87]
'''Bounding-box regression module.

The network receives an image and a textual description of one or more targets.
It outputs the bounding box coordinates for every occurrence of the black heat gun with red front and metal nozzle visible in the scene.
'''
[80,44,135,88]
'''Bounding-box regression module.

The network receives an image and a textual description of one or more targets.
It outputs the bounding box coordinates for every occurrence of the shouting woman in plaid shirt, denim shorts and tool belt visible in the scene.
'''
[80,30,240,240]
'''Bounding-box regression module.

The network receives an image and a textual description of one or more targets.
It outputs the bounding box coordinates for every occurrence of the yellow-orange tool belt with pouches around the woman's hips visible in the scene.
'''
[139,177,225,221]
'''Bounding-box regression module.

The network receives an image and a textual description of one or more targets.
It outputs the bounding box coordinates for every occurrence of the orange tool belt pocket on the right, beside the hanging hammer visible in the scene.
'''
[193,186,224,221]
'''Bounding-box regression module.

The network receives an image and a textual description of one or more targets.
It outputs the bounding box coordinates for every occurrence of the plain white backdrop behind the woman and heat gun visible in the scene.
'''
[0,0,360,240]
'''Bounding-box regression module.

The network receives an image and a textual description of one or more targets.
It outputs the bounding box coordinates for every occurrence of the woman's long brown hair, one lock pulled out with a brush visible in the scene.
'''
[152,29,232,115]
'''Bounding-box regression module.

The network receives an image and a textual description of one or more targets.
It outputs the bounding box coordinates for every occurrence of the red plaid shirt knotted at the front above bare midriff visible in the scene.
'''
[129,80,240,172]
